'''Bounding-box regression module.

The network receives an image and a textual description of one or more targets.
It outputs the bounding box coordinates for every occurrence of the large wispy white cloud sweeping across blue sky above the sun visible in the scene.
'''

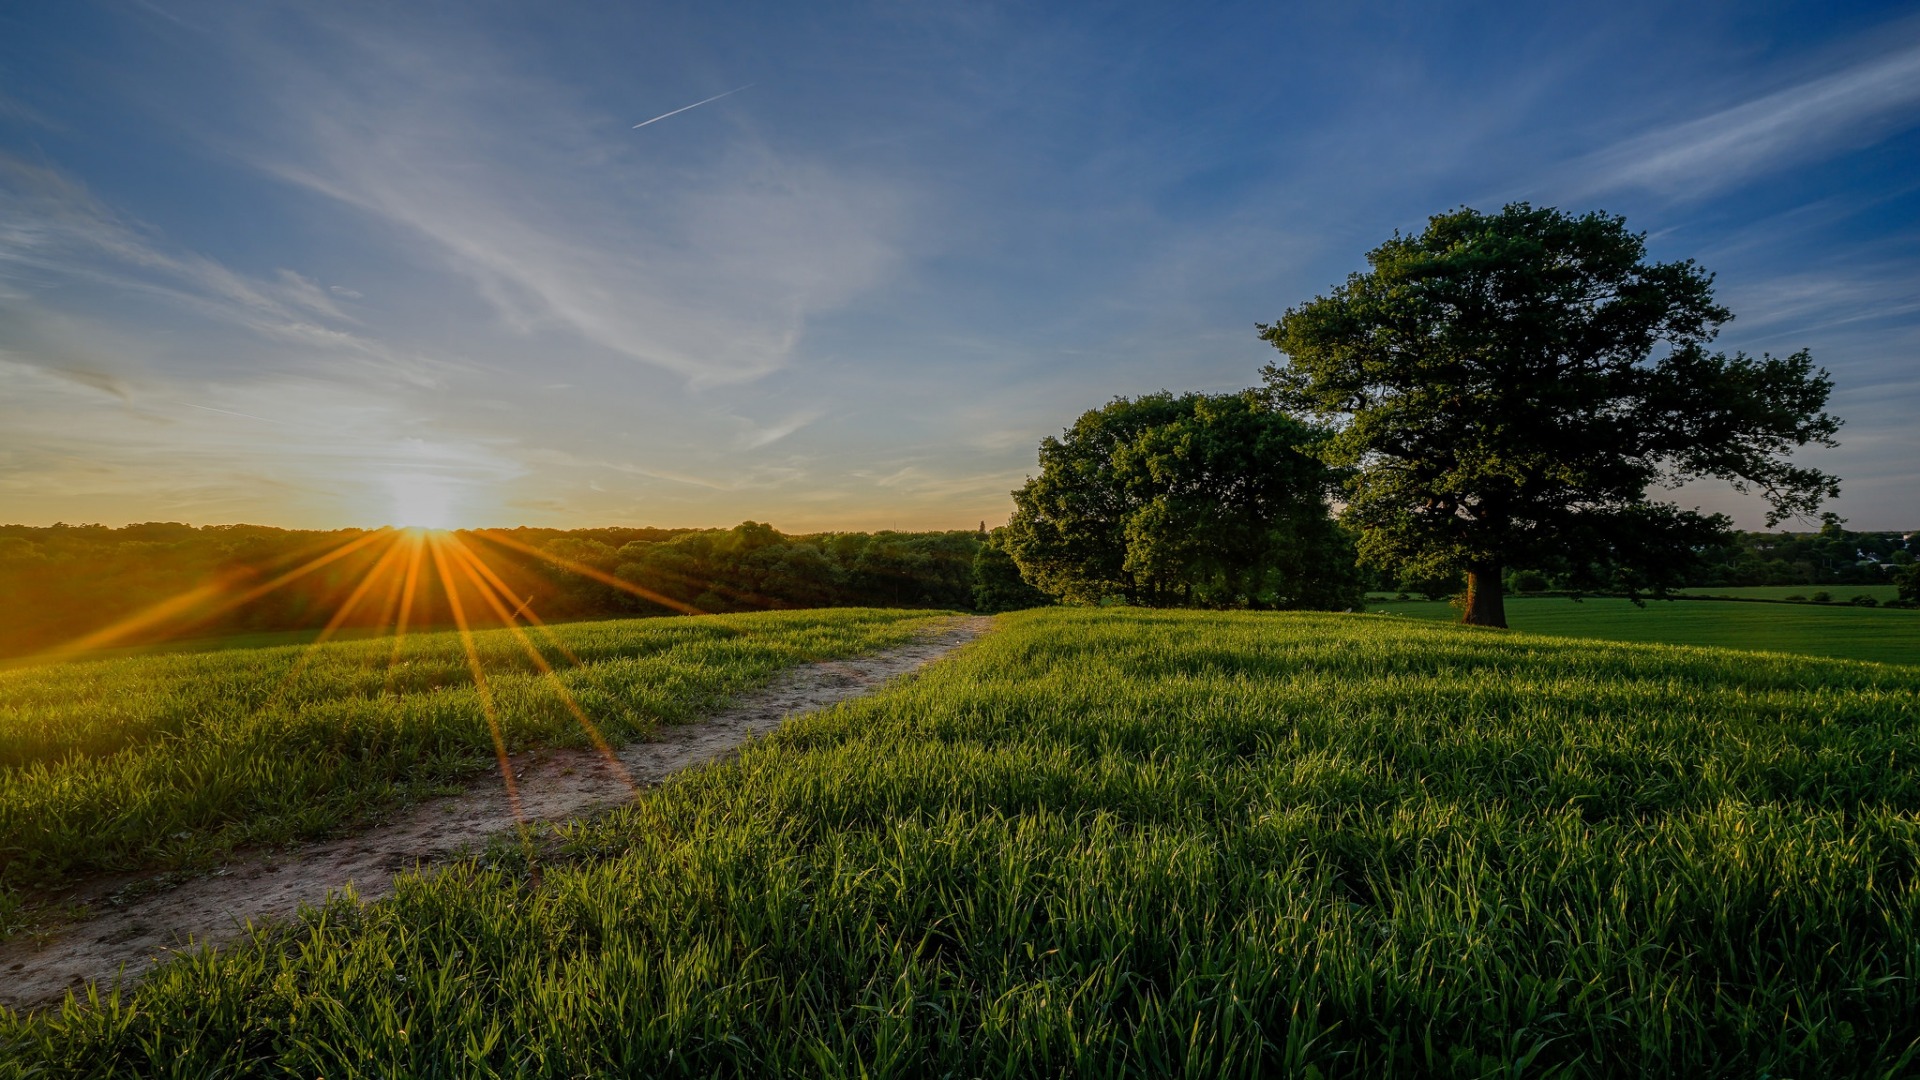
[228,21,904,384]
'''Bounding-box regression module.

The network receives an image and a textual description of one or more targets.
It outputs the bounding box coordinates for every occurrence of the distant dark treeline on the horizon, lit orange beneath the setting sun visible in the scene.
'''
[0,521,1041,655]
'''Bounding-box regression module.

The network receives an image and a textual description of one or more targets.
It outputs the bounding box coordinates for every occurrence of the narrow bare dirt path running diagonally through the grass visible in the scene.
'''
[0,617,991,1009]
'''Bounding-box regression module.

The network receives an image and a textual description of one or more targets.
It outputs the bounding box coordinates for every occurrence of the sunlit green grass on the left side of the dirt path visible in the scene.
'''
[0,609,944,899]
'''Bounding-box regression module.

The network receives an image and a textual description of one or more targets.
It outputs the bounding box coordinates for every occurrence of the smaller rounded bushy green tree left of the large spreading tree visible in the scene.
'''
[1004,392,1361,609]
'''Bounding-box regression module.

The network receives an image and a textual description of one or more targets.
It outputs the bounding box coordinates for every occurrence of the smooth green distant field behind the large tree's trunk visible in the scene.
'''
[1367,596,1920,665]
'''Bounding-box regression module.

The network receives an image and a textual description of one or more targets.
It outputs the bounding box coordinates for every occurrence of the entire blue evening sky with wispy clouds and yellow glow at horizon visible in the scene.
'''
[0,0,1920,530]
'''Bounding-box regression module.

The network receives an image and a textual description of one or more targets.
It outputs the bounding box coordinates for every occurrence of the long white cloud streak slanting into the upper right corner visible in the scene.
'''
[1567,36,1920,198]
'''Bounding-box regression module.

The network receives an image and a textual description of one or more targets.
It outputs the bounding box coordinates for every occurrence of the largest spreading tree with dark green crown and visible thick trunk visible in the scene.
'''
[1260,204,1839,626]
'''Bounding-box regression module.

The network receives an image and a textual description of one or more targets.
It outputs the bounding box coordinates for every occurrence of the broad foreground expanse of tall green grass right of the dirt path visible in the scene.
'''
[15,611,1920,1076]
